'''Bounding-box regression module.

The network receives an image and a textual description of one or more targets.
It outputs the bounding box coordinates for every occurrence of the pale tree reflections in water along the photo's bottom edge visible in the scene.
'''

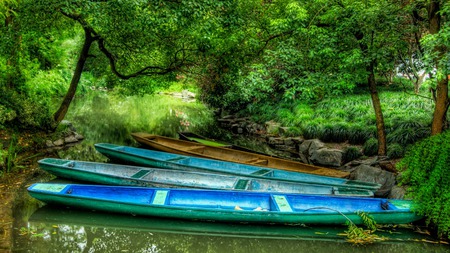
[27,222,448,253]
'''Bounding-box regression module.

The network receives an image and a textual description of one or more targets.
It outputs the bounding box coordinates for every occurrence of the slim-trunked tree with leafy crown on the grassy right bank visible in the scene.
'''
[314,0,410,156]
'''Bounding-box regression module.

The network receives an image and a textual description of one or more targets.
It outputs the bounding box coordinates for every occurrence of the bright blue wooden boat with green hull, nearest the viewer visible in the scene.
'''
[28,183,421,225]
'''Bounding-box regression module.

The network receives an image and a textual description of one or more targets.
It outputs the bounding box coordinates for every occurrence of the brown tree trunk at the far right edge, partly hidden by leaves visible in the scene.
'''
[428,0,449,135]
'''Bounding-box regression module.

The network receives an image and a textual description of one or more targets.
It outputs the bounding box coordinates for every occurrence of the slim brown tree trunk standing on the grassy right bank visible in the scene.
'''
[367,60,386,156]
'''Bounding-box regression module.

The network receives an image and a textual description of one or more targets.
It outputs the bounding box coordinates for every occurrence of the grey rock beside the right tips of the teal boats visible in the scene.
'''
[350,164,395,197]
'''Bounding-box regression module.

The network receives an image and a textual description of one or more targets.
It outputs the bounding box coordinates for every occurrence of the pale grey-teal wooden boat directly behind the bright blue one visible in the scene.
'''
[38,158,373,197]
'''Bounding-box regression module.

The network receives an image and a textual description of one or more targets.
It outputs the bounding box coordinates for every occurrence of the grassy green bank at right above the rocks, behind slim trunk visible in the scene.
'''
[243,91,434,157]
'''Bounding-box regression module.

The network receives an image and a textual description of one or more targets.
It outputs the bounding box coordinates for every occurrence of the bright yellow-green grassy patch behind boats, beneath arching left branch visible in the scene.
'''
[67,91,214,144]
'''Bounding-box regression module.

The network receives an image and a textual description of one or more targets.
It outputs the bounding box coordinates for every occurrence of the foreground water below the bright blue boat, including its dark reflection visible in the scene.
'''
[14,206,448,253]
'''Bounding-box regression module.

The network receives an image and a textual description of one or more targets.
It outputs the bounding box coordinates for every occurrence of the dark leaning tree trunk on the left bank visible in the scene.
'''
[53,29,95,127]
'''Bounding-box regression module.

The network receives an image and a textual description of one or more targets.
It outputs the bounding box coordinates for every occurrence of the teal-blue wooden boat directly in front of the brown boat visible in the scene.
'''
[94,143,381,191]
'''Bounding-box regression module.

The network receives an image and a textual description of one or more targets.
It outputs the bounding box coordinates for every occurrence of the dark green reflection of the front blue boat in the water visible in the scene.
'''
[28,205,431,242]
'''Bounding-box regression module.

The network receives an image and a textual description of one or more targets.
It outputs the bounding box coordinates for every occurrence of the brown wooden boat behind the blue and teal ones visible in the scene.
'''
[131,133,350,178]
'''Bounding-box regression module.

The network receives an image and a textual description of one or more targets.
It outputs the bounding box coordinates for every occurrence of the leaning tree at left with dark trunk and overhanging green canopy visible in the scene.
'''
[30,0,236,126]
